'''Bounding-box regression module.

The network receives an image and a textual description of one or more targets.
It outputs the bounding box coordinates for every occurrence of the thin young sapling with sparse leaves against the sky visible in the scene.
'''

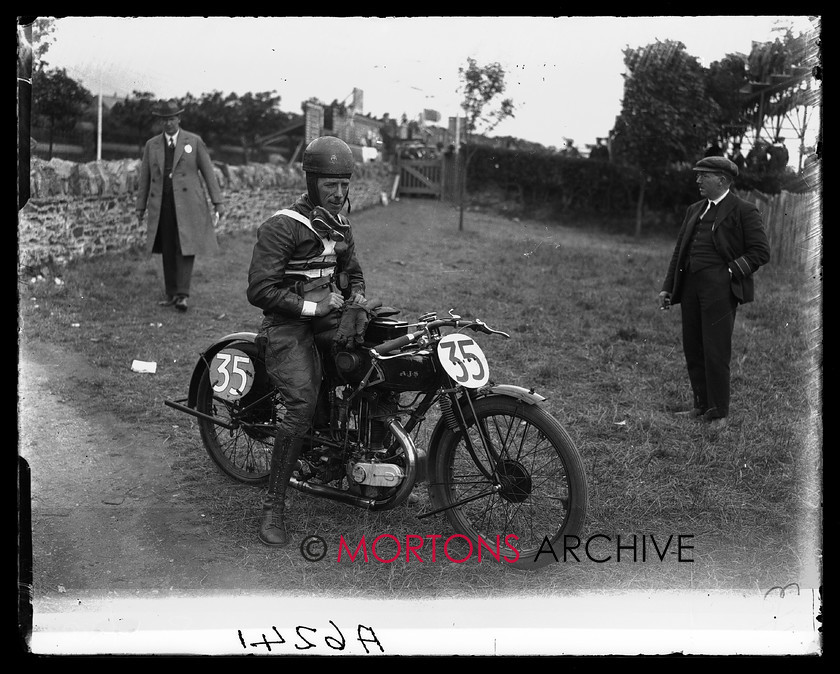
[458,57,514,230]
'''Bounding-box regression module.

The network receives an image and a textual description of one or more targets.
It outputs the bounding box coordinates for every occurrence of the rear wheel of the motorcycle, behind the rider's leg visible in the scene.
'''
[196,344,277,484]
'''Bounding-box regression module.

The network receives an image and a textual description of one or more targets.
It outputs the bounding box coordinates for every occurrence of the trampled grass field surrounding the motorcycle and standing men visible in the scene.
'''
[19,200,822,598]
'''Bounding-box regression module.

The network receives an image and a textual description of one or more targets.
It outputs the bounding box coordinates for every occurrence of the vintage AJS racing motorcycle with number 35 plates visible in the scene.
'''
[165,311,588,569]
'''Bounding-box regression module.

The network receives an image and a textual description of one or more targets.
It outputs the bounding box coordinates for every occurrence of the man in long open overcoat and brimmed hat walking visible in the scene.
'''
[135,101,224,311]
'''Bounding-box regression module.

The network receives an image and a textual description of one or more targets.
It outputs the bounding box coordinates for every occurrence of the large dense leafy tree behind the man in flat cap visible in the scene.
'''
[612,40,720,236]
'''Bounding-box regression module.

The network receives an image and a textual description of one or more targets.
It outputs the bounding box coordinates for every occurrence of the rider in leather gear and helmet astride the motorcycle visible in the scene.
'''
[247,136,365,546]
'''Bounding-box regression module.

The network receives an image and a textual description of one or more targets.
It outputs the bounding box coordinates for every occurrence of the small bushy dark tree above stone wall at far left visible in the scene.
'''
[32,68,93,159]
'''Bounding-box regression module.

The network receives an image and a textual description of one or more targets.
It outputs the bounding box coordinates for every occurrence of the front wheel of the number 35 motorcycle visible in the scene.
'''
[429,396,588,570]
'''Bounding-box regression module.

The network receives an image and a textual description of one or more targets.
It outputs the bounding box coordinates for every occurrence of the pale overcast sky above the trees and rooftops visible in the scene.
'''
[34,15,811,149]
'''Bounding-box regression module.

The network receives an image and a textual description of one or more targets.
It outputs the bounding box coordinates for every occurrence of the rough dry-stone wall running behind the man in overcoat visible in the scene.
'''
[18,159,394,272]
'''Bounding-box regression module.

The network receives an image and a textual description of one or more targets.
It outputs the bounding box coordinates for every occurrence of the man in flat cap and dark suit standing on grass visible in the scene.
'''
[659,157,770,429]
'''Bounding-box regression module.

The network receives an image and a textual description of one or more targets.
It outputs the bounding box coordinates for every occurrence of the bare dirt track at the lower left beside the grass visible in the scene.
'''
[18,343,278,648]
